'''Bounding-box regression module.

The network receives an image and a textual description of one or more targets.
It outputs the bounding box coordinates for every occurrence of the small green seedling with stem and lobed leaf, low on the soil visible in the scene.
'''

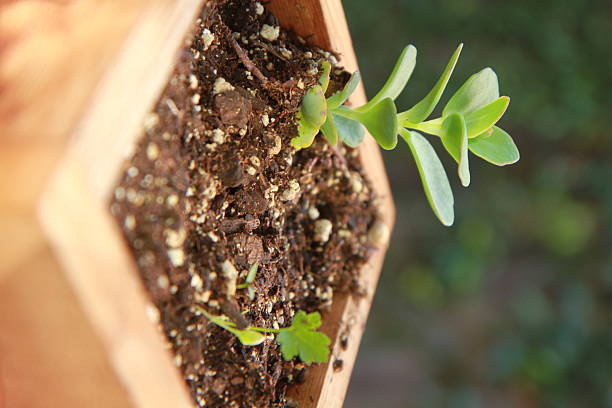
[193,305,331,364]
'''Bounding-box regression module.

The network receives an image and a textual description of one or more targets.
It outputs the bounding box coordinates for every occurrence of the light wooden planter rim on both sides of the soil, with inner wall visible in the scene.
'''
[40,0,394,408]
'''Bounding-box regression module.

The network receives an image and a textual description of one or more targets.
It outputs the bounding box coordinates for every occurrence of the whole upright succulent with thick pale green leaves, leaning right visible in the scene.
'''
[291,44,520,226]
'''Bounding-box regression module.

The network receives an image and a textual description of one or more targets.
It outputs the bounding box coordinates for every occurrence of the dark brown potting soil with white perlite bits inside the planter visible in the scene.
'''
[111,0,376,408]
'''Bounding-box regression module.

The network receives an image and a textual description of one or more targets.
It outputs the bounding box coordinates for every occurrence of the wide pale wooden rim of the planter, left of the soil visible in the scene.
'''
[39,0,202,408]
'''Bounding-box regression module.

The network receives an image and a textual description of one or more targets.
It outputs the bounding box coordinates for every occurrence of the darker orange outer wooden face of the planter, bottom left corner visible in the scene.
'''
[0,245,131,408]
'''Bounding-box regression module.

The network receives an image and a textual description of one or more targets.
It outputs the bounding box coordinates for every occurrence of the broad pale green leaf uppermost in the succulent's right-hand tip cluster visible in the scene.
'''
[442,68,499,116]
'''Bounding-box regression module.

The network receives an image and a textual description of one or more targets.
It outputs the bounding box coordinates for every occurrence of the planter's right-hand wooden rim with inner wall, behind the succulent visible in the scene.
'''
[268,0,395,408]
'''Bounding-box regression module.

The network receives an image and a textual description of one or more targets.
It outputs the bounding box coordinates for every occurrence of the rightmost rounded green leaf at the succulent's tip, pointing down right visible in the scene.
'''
[469,126,521,166]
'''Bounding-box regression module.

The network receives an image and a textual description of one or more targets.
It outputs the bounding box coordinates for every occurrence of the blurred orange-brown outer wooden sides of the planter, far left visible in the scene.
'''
[0,0,182,408]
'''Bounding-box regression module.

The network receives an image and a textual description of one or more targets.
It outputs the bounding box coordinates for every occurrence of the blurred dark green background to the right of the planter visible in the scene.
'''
[344,0,612,408]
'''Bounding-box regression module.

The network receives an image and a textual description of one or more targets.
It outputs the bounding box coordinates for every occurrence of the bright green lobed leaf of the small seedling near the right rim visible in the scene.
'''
[276,311,331,364]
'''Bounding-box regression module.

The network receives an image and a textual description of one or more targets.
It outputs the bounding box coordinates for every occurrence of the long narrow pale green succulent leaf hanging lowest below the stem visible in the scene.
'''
[400,129,455,226]
